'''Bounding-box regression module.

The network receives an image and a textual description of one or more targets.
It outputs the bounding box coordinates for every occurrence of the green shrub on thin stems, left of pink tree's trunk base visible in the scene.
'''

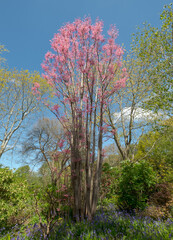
[30,178,72,237]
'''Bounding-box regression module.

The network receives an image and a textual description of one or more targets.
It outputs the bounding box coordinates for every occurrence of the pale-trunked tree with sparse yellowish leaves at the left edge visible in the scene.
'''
[0,68,44,157]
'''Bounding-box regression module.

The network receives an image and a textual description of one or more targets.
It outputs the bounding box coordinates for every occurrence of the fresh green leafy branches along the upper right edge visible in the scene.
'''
[133,4,173,115]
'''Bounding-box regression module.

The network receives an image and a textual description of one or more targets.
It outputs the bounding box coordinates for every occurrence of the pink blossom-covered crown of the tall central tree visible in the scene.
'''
[35,18,127,195]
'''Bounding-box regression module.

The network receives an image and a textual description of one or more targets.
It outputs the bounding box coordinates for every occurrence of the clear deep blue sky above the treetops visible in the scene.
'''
[0,0,171,170]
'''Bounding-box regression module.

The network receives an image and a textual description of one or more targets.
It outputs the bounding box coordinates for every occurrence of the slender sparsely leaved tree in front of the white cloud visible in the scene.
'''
[106,39,157,160]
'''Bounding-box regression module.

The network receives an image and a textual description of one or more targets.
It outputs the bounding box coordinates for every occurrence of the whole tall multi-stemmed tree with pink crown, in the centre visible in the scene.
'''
[33,18,126,219]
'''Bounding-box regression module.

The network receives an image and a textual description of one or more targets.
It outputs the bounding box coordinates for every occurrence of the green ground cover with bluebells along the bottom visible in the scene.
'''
[0,206,173,240]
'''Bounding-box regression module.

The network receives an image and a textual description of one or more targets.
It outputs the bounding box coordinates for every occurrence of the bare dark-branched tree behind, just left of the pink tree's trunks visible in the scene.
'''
[21,118,69,185]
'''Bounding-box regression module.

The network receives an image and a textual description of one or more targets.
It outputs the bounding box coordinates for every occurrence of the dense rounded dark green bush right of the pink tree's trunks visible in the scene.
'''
[118,161,156,210]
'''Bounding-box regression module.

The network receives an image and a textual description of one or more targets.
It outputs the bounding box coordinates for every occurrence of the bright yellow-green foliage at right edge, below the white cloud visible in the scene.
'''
[135,119,173,182]
